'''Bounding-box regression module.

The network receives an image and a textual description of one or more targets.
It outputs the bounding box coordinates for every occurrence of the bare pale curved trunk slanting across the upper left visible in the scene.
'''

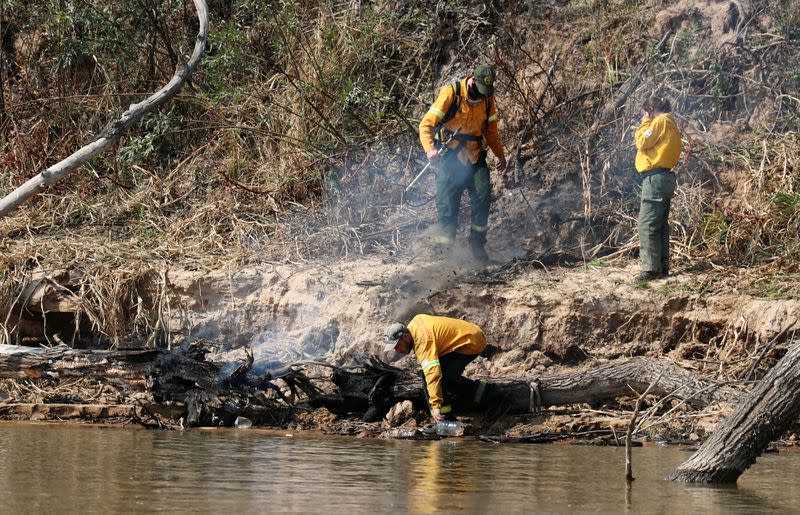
[0,0,208,216]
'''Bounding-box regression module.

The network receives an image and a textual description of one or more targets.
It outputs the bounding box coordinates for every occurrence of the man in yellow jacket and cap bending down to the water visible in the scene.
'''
[383,315,488,422]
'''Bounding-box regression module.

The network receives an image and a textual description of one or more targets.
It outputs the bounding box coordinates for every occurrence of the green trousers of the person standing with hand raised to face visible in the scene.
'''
[638,168,675,273]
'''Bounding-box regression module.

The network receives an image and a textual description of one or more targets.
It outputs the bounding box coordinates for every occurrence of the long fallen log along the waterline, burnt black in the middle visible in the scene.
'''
[0,345,742,432]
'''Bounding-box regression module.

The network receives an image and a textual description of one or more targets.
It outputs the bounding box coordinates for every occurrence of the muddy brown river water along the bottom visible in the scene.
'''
[0,424,800,514]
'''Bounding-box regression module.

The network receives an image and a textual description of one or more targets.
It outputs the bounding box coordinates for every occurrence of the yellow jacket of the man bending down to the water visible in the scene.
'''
[408,315,486,410]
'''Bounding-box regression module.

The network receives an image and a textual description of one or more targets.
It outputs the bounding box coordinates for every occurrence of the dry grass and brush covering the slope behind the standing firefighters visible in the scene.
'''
[0,0,800,344]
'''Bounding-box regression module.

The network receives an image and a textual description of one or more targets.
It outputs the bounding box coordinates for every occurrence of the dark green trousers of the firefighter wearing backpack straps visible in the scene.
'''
[436,152,492,247]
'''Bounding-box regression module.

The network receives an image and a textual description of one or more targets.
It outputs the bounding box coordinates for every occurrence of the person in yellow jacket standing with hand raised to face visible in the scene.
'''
[635,96,688,281]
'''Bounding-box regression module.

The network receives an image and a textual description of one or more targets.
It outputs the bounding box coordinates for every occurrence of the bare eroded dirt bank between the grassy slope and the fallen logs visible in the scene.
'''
[144,257,800,377]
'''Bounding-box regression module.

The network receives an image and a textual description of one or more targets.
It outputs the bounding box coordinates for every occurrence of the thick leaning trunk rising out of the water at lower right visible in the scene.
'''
[667,344,800,483]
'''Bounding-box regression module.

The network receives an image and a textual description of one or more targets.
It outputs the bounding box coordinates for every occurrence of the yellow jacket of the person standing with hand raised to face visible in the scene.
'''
[635,113,682,173]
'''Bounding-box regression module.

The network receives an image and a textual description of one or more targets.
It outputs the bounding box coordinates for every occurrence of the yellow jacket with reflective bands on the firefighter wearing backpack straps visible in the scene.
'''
[419,79,505,164]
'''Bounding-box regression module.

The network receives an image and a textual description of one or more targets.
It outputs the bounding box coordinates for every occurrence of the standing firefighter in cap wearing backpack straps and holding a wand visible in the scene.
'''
[419,65,506,263]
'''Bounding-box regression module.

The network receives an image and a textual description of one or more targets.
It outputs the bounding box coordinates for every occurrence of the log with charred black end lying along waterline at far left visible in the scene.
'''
[0,345,292,427]
